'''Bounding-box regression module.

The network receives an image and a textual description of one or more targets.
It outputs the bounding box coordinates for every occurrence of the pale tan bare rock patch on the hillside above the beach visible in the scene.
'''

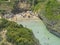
[17,0,31,11]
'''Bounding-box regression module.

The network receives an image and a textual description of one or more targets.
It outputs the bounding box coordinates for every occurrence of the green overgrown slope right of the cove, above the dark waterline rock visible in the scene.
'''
[33,0,60,35]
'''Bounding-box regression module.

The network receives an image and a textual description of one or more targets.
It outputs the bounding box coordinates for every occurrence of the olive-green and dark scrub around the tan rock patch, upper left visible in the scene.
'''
[0,0,32,13]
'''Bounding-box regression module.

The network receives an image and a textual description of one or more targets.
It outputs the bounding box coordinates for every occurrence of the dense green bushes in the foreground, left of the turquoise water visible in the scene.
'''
[0,19,37,45]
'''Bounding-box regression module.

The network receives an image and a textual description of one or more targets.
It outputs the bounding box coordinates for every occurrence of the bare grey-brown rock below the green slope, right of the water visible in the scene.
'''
[39,14,60,38]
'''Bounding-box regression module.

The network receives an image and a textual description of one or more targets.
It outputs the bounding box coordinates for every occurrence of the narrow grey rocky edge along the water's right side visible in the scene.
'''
[38,15,60,38]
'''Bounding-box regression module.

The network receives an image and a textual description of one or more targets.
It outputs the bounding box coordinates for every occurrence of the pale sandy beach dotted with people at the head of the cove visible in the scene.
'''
[3,11,39,21]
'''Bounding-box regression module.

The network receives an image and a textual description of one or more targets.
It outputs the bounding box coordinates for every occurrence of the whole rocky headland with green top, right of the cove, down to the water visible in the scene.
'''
[39,0,60,37]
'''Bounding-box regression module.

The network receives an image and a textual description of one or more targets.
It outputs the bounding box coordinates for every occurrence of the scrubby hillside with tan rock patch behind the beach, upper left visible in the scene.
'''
[0,0,31,13]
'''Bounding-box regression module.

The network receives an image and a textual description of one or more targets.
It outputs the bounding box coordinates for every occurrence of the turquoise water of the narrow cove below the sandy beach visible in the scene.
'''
[17,20,60,45]
